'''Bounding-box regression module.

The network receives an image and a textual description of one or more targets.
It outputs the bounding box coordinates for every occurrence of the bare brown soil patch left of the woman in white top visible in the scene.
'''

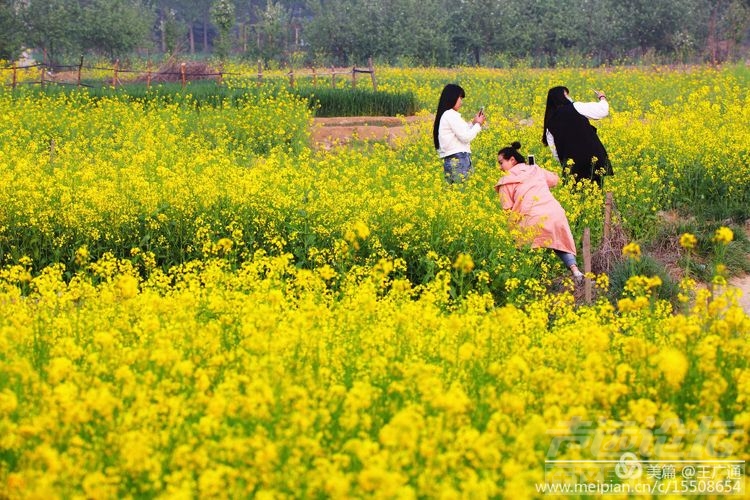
[312,116,429,149]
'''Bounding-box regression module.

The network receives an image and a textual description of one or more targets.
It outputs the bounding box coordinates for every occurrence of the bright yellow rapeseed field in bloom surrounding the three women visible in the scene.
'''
[0,66,750,499]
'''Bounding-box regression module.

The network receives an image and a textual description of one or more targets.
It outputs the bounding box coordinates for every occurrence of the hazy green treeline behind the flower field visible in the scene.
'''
[0,0,750,66]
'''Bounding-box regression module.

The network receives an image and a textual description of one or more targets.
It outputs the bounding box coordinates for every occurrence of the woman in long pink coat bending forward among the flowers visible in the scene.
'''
[495,142,583,283]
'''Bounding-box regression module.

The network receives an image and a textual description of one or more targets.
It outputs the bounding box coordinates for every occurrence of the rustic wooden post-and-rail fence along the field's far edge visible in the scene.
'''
[0,57,378,91]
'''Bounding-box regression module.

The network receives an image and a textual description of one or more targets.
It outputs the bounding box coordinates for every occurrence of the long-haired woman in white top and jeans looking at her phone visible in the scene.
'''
[432,83,485,184]
